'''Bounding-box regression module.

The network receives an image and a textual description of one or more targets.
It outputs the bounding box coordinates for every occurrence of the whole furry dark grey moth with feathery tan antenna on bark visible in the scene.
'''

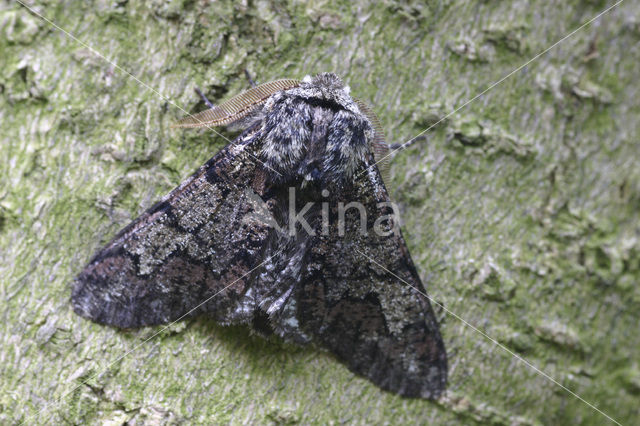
[71,73,447,399]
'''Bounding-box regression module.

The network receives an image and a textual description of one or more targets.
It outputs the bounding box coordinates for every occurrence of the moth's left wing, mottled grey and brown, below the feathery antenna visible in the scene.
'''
[72,127,273,328]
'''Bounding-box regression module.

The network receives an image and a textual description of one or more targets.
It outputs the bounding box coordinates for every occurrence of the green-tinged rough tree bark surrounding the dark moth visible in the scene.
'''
[0,0,640,424]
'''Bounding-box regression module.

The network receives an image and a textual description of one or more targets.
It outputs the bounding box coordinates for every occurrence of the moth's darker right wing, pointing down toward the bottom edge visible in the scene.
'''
[278,152,447,399]
